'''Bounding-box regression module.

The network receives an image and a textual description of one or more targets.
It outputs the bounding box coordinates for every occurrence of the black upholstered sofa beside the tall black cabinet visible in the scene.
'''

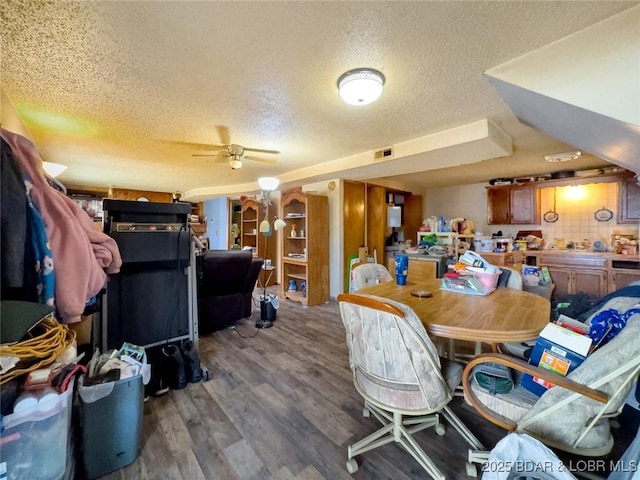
[198,250,263,335]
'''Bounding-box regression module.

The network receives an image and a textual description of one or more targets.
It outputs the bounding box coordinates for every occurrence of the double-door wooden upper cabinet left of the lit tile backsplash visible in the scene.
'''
[487,185,540,225]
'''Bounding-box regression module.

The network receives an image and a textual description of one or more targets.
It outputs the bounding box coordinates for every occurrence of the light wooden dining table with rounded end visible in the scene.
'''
[356,279,551,344]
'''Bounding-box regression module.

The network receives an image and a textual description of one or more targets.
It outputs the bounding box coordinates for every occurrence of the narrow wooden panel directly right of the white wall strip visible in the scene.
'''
[342,181,365,292]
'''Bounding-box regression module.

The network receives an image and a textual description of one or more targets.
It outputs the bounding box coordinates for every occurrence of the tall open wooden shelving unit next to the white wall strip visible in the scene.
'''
[280,190,329,306]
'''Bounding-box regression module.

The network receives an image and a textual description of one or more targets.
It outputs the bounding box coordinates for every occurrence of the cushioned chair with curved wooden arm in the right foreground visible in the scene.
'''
[462,298,640,474]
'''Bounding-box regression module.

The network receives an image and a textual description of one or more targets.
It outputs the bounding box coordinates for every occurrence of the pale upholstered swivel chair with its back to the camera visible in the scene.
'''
[338,294,484,480]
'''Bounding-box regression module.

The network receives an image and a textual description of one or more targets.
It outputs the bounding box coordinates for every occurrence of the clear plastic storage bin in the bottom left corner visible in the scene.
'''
[0,383,73,480]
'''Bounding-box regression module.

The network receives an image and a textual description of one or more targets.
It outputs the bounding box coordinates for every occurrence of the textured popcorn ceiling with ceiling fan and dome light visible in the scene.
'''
[0,0,639,198]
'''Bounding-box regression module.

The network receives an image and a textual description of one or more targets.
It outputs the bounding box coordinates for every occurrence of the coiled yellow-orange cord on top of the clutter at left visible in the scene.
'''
[0,316,76,385]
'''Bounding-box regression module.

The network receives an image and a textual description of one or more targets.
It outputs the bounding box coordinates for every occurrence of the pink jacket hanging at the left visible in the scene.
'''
[0,128,122,323]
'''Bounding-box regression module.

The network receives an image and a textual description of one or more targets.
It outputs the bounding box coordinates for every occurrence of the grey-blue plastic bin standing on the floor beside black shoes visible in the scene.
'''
[78,375,144,478]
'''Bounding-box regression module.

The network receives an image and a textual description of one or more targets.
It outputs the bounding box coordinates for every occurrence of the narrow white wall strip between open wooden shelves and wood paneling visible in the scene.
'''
[302,178,344,299]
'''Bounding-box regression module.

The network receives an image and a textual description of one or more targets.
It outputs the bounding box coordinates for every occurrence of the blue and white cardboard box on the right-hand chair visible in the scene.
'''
[520,323,591,396]
